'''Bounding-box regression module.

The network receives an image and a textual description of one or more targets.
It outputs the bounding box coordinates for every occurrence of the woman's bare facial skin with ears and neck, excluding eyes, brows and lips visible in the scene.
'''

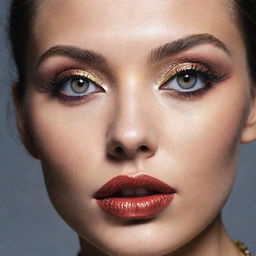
[16,0,256,256]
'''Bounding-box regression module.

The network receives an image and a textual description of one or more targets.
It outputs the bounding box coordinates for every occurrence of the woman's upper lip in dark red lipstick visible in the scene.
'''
[94,174,175,199]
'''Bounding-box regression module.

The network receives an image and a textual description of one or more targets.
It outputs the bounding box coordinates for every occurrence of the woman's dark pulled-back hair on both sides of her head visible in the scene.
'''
[9,0,256,97]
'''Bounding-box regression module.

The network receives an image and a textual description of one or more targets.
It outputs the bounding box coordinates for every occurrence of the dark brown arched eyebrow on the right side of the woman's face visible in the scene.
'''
[149,34,231,62]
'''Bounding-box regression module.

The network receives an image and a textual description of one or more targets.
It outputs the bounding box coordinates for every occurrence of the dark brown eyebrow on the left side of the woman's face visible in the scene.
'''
[37,45,106,66]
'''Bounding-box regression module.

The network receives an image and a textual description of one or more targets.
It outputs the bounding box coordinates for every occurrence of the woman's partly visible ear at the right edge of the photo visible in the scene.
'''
[241,87,256,143]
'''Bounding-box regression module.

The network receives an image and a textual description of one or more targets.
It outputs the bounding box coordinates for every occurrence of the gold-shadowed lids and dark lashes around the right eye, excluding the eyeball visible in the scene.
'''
[160,63,226,100]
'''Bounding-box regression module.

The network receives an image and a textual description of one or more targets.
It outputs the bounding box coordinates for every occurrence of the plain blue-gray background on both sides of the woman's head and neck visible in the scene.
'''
[0,0,256,256]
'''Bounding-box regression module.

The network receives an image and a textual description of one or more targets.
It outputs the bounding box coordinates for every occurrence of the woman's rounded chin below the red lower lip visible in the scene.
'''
[79,221,184,256]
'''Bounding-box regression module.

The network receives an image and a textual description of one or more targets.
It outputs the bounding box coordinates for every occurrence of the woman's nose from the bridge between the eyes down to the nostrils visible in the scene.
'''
[107,76,157,158]
